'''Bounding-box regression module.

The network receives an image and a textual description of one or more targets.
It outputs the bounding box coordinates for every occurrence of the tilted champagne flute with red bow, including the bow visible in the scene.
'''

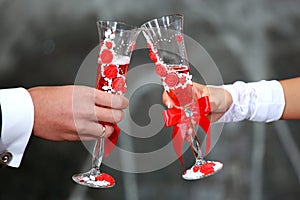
[141,14,223,180]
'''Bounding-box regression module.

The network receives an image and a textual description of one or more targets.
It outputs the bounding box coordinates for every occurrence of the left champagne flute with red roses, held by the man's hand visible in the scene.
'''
[72,21,139,188]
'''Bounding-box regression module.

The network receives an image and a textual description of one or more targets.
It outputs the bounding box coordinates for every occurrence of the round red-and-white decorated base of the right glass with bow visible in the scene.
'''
[182,161,223,181]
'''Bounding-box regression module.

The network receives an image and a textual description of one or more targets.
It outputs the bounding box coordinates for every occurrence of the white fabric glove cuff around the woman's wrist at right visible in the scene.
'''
[217,80,285,122]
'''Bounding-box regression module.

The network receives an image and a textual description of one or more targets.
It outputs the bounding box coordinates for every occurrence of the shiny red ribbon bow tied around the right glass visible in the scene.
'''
[162,96,210,167]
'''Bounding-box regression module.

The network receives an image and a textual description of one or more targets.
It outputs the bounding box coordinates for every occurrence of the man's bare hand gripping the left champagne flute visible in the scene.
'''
[28,86,128,141]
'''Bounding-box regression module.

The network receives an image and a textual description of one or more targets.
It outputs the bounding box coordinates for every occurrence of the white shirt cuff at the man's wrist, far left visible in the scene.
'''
[0,88,34,167]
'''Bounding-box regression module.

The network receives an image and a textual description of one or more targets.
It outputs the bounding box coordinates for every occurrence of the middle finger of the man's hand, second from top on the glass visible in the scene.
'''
[95,106,124,123]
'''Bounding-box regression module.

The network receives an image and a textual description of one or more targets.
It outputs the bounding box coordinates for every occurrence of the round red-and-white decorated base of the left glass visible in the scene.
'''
[72,169,115,188]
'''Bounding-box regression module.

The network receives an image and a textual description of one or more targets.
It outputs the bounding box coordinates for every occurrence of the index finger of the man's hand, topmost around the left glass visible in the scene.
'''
[95,90,129,109]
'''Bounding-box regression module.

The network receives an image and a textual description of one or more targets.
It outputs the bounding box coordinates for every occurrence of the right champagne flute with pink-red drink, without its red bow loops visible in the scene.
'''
[141,14,223,180]
